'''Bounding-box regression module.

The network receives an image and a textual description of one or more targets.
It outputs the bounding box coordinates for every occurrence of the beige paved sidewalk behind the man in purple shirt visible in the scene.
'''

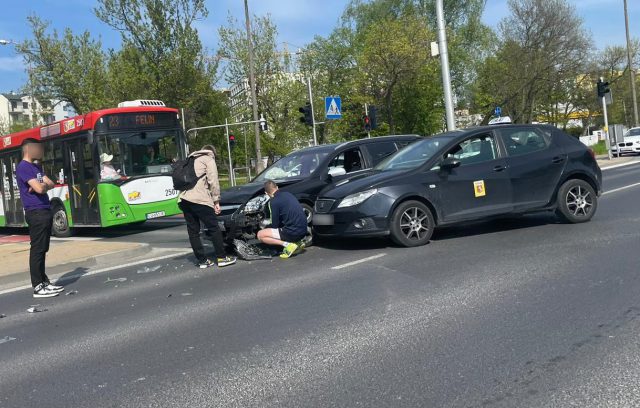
[0,239,151,289]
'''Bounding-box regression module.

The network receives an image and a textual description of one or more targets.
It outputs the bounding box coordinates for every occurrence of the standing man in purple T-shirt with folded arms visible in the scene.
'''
[16,138,64,298]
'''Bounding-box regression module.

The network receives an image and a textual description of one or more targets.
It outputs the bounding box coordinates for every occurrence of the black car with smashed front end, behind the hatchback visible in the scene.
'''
[219,135,421,239]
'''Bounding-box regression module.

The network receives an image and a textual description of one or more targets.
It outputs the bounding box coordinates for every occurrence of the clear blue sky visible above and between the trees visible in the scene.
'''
[0,0,640,93]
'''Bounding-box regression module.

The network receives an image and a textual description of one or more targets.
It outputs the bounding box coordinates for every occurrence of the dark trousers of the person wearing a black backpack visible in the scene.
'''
[180,200,226,262]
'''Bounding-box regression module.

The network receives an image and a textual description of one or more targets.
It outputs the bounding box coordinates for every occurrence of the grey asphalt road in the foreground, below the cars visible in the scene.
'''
[0,165,640,408]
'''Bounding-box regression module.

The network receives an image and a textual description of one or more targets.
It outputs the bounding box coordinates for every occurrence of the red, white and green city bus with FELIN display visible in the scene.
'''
[0,100,188,237]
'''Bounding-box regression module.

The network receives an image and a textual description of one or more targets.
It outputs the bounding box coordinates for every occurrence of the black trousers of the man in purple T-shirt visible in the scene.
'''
[25,210,53,288]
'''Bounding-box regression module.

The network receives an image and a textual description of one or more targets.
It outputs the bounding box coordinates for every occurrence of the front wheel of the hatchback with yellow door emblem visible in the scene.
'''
[390,200,435,247]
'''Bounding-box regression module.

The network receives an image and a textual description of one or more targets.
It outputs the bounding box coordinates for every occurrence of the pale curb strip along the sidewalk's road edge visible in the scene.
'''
[0,243,152,292]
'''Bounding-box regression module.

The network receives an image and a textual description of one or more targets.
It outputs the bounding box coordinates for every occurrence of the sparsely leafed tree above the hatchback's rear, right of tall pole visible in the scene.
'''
[475,0,592,123]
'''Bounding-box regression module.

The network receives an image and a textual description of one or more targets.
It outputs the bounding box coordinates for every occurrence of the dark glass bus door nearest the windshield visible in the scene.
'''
[65,138,100,225]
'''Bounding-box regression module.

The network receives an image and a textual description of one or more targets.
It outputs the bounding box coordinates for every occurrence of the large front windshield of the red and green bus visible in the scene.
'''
[98,129,180,180]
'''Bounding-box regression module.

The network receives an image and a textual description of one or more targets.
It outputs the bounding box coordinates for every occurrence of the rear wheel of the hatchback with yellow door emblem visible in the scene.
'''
[556,179,598,224]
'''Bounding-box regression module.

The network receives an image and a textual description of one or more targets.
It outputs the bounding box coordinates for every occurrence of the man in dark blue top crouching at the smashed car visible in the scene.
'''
[258,180,307,259]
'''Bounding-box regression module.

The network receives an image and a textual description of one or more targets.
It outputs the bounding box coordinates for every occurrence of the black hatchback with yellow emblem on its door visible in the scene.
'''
[313,125,602,247]
